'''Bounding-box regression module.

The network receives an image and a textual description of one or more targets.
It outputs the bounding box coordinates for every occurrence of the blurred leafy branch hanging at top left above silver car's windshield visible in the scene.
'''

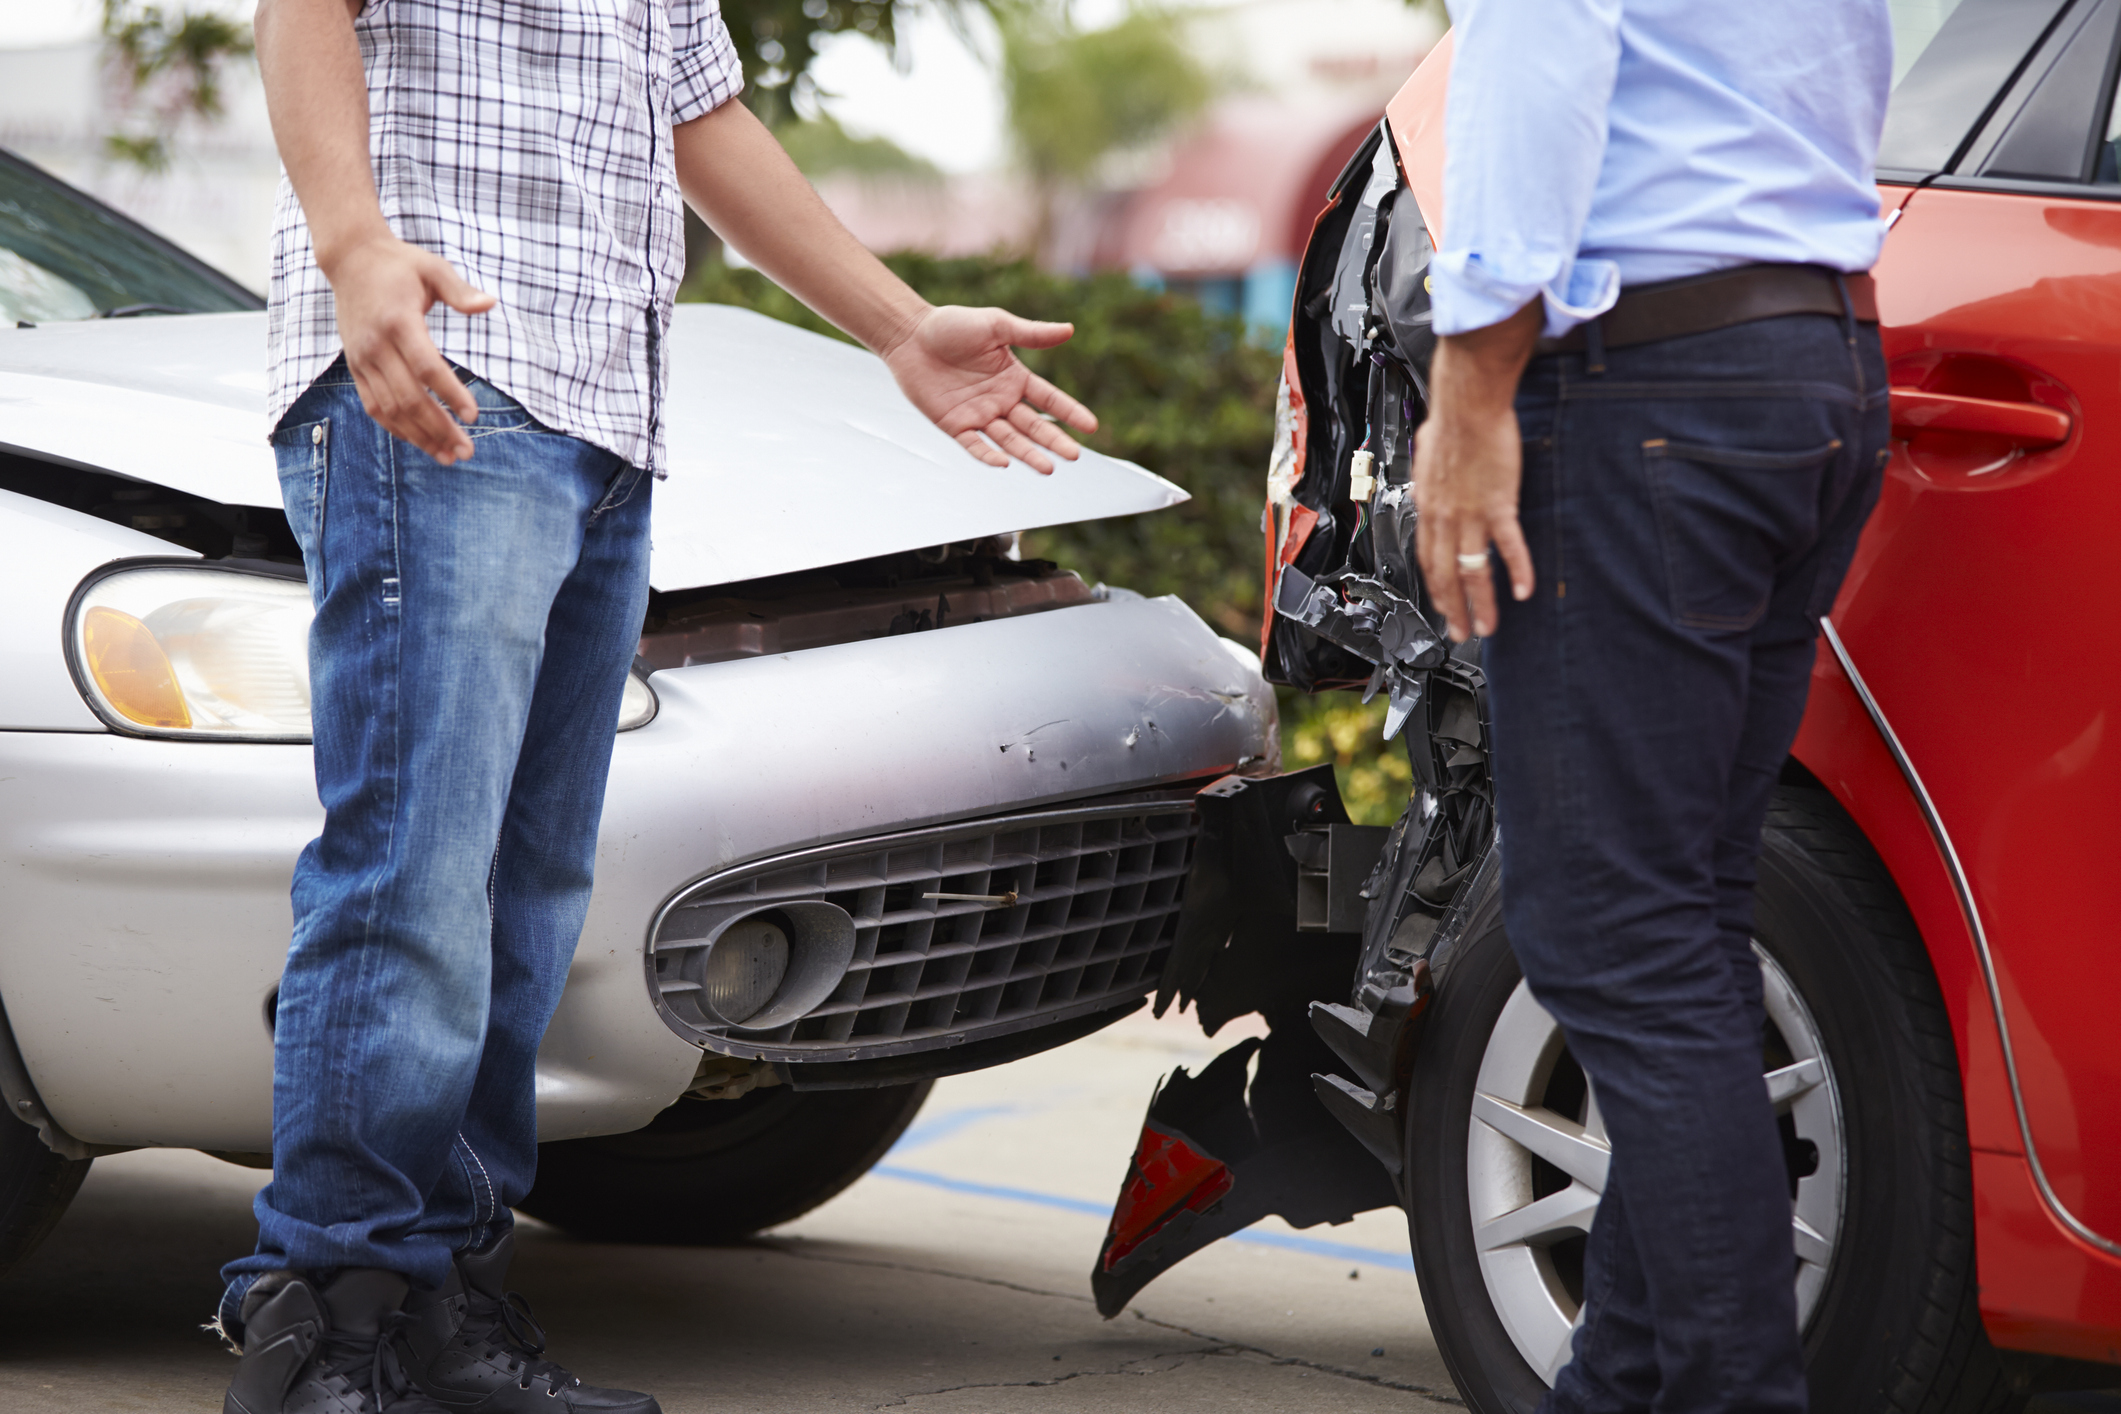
[104,0,257,172]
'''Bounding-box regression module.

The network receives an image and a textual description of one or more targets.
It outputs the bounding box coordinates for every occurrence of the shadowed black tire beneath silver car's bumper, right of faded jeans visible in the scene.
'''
[520,1081,931,1244]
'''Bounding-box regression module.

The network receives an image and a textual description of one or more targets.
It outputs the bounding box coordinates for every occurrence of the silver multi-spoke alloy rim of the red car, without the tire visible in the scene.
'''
[1466,943,1843,1384]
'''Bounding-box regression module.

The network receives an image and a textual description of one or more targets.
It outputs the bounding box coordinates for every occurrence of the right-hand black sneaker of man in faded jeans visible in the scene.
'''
[399,1232,662,1414]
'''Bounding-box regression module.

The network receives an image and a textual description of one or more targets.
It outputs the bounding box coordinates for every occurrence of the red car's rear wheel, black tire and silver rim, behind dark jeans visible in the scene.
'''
[1406,789,2021,1414]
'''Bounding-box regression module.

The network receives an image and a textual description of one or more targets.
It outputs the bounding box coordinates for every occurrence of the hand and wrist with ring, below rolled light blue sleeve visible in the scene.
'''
[1415,299,1542,642]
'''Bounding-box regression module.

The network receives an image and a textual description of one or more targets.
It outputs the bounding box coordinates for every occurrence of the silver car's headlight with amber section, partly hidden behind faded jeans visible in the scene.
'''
[66,564,655,742]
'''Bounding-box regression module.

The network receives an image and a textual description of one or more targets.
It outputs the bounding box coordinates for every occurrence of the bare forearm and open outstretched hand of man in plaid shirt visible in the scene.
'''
[677,102,1097,471]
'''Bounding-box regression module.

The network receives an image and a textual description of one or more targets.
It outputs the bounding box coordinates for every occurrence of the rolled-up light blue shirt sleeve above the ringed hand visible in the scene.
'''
[1434,0,1620,337]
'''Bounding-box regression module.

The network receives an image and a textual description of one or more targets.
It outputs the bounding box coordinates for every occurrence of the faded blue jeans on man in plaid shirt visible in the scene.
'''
[221,360,653,1331]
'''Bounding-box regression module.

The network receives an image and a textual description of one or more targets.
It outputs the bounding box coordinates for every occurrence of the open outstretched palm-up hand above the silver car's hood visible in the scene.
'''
[882,305,1097,473]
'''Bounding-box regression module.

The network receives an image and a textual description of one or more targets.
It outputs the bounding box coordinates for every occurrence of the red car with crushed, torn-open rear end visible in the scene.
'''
[1094,0,2121,1414]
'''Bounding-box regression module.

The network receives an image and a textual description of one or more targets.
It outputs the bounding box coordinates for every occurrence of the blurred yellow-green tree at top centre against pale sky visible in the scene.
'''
[995,4,1215,252]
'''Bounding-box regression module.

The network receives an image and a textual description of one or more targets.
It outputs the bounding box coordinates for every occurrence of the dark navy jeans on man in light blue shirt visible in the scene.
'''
[1485,316,1890,1414]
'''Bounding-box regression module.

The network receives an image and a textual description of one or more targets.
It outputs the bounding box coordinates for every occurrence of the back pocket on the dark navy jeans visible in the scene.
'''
[1642,437,1841,630]
